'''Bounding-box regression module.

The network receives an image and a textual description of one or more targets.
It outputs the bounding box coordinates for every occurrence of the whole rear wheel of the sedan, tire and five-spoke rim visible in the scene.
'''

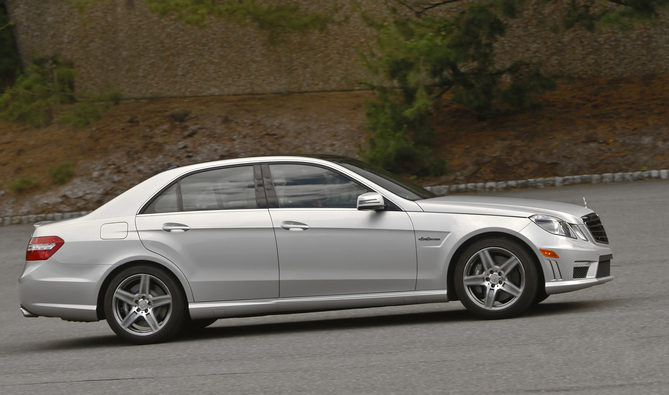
[104,265,186,344]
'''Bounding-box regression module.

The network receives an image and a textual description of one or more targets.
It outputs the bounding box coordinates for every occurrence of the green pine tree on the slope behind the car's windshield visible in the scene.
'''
[360,0,555,174]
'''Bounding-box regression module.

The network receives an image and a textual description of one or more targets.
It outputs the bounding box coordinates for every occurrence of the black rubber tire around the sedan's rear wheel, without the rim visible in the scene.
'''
[104,265,186,344]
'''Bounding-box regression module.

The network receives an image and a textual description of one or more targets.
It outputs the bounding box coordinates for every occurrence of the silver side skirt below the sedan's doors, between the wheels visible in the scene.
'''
[188,290,448,319]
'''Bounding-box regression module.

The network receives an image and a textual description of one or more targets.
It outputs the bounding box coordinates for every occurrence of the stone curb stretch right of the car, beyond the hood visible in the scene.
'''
[425,169,669,196]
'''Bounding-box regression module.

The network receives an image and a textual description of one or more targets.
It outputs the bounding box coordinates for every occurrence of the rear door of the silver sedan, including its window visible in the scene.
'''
[136,165,279,302]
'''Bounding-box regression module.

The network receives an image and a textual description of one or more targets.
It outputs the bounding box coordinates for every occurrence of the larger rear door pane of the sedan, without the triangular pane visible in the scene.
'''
[180,166,258,211]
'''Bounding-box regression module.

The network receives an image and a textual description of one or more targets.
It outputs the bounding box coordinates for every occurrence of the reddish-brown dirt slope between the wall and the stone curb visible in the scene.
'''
[0,76,669,217]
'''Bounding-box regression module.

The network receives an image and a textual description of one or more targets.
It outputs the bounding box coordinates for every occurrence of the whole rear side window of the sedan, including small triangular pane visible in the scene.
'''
[143,166,258,214]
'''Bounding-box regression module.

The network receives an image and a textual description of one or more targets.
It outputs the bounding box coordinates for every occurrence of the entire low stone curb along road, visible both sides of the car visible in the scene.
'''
[0,169,669,226]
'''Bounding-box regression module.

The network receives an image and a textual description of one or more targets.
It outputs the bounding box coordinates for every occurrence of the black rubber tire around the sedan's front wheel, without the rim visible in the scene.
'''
[453,238,538,319]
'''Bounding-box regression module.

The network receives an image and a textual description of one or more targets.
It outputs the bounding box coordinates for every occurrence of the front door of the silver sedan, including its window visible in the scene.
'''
[265,164,417,297]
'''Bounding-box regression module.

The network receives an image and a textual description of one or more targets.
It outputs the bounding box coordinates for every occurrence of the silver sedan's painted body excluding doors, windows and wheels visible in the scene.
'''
[19,157,613,321]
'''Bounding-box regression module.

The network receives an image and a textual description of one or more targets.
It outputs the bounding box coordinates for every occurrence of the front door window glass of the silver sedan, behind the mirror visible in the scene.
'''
[269,164,369,208]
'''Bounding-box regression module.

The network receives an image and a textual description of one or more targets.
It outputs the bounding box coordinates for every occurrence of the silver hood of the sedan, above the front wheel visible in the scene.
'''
[416,195,592,223]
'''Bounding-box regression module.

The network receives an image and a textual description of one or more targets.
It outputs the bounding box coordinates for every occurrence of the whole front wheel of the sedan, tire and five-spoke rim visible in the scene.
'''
[454,238,538,319]
